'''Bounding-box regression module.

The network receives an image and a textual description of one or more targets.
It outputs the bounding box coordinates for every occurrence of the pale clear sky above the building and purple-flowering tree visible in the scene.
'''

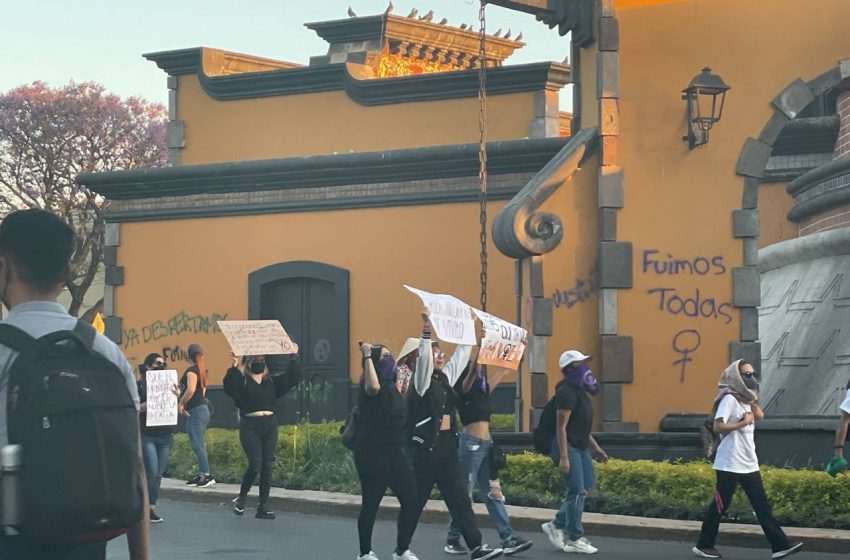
[0,0,570,110]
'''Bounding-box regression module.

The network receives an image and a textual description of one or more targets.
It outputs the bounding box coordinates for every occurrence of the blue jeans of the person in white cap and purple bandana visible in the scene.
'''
[549,440,596,541]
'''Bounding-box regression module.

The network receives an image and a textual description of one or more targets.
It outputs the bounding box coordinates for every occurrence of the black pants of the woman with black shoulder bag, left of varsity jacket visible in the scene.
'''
[354,445,419,554]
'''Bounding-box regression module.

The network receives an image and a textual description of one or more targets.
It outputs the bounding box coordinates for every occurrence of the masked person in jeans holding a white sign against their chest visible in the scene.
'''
[136,353,178,523]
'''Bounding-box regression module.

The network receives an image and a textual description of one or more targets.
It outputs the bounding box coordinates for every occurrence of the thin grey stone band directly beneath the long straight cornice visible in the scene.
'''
[106,187,520,223]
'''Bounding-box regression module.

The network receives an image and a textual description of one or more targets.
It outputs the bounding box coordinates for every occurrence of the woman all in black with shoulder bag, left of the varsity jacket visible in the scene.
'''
[354,342,418,560]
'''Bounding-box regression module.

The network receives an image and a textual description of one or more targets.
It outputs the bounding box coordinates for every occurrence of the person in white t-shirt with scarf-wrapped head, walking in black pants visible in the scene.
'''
[692,360,803,558]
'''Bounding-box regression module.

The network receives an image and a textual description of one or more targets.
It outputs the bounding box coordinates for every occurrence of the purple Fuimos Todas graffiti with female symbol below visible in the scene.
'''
[641,249,733,383]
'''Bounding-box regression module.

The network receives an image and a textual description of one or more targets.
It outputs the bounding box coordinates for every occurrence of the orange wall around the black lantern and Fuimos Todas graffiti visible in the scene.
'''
[618,0,850,431]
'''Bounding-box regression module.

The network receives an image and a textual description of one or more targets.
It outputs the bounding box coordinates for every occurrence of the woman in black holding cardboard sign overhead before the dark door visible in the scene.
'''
[222,354,301,519]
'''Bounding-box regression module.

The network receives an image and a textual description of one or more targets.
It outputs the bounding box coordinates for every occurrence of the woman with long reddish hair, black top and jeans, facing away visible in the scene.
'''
[178,344,215,488]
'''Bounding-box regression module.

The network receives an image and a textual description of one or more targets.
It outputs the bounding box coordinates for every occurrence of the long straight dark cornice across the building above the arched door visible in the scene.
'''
[76,138,568,200]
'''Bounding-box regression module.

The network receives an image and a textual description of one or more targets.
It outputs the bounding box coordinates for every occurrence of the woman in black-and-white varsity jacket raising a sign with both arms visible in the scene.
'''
[409,308,502,560]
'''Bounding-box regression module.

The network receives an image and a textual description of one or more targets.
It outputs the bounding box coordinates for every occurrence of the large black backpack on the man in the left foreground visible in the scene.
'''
[0,322,144,542]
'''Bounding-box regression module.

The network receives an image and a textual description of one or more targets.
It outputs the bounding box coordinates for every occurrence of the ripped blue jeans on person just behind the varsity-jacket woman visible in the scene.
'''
[446,433,514,542]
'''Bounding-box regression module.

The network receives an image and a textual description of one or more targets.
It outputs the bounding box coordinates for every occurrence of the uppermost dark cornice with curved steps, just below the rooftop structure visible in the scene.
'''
[144,48,570,106]
